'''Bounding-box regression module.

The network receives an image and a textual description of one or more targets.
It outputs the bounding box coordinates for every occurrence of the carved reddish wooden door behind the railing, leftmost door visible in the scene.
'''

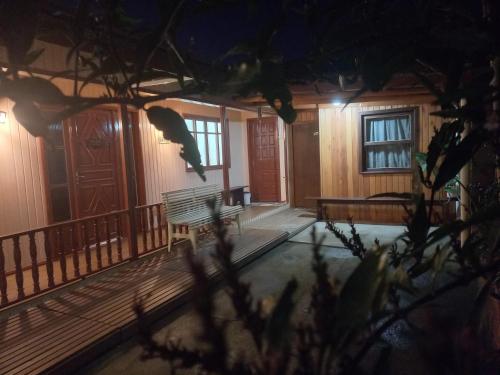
[68,109,123,219]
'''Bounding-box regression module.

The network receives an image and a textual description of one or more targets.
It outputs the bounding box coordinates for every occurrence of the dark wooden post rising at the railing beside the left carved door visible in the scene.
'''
[120,104,138,258]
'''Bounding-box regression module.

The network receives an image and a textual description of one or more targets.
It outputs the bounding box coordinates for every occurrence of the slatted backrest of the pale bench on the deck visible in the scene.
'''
[161,185,222,219]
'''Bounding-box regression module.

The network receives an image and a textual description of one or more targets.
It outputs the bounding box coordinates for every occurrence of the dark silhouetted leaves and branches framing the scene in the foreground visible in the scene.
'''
[0,0,500,374]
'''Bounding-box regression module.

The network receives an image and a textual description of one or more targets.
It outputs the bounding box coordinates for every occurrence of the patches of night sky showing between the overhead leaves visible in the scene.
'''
[50,0,316,61]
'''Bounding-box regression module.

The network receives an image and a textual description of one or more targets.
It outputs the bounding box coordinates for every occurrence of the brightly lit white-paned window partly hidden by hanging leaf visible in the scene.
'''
[184,116,222,170]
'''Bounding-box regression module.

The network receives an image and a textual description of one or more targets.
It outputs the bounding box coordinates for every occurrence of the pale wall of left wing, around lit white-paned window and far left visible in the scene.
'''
[0,78,248,235]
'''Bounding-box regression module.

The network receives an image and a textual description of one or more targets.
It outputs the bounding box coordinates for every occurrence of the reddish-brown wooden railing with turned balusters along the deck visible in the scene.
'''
[0,203,167,308]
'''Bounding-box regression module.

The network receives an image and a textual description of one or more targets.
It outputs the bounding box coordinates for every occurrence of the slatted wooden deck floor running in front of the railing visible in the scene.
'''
[0,212,312,374]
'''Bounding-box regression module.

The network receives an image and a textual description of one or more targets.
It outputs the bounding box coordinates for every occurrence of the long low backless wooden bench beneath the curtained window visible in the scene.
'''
[306,197,457,220]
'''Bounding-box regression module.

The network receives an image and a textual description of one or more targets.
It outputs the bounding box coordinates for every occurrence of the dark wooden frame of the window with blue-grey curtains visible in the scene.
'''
[358,107,419,174]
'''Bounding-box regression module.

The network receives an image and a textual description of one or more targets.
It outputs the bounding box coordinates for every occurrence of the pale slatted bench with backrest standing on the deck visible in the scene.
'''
[161,185,243,251]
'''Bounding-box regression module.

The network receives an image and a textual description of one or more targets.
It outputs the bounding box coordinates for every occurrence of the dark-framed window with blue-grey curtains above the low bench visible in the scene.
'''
[360,108,417,173]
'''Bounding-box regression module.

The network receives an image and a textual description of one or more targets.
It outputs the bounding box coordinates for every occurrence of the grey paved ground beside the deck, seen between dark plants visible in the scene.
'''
[81,224,484,375]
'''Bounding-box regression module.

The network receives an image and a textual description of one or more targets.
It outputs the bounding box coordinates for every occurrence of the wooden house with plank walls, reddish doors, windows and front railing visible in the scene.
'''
[0,36,448,306]
